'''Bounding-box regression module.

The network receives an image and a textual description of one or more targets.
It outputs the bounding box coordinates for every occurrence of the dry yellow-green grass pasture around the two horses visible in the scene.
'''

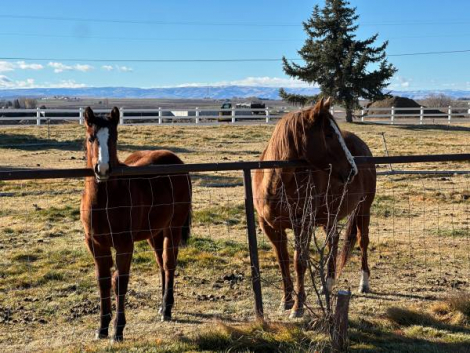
[0,119,470,352]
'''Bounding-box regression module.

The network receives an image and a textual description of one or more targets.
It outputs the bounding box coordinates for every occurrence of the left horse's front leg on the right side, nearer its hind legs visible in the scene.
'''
[113,243,134,342]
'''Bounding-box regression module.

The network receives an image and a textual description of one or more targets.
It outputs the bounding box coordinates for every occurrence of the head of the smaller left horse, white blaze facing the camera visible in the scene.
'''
[85,107,119,182]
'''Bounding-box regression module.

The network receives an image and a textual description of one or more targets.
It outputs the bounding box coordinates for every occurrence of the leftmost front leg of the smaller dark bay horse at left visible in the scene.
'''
[86,238,113,339]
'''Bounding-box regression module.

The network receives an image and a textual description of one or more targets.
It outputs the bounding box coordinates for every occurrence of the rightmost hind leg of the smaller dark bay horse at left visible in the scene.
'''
[162,228,181,321]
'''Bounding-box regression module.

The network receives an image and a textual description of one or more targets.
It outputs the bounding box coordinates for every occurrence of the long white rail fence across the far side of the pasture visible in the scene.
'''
[0,105,470,125]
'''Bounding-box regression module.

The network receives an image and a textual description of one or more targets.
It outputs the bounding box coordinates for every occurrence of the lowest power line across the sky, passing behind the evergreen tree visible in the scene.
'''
[0,49,470,63]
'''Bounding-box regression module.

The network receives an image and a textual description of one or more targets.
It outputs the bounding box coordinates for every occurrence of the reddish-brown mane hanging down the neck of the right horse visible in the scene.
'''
[265,107,322,160]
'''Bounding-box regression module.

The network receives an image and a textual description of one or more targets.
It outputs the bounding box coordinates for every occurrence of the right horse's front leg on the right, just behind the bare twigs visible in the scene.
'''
[290,227,311,318]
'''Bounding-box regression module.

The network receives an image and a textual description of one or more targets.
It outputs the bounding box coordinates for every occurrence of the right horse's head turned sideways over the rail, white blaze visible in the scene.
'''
[303,98,358,184]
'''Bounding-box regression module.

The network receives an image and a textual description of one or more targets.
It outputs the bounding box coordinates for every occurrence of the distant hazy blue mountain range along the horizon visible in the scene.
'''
[0,86,470,99]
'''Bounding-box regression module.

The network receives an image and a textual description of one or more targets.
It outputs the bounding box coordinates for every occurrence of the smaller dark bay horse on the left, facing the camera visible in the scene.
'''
[80,107,192,341]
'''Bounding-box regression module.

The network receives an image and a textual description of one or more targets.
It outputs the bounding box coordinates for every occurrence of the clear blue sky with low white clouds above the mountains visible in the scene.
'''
[0,0,470,90]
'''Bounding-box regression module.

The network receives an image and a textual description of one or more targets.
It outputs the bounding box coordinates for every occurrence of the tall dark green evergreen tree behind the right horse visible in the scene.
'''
[279,0,397,122]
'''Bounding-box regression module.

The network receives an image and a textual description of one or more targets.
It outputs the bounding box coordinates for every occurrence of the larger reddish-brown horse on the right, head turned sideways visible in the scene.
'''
[253,99,376,317]
